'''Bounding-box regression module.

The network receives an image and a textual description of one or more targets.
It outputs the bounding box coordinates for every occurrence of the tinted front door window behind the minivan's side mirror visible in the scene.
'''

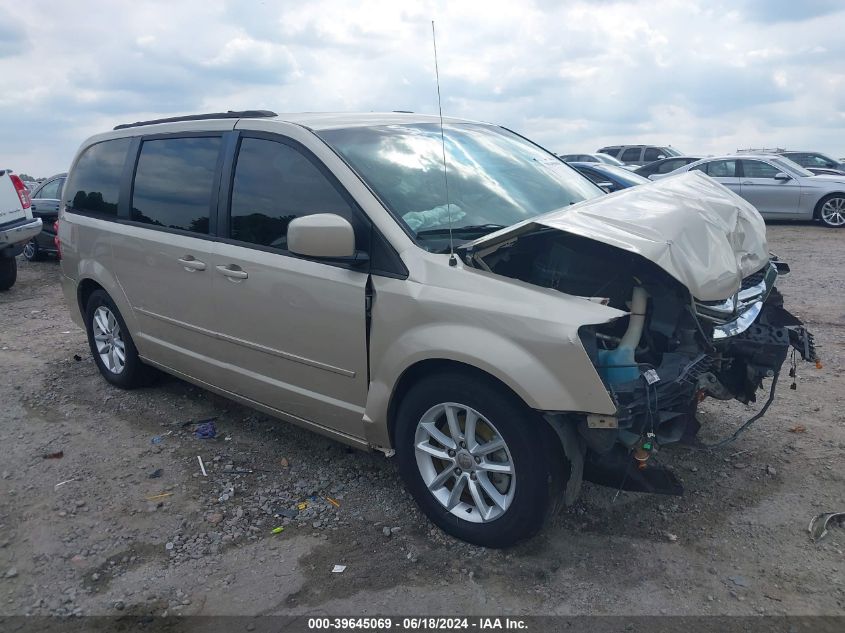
[229,138,357,251]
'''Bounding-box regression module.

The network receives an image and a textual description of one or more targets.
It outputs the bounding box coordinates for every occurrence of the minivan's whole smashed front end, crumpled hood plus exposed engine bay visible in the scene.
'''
[465,170,817,503]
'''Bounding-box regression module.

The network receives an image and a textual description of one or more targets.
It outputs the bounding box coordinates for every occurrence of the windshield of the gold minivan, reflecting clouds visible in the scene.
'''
[318,123,603,251]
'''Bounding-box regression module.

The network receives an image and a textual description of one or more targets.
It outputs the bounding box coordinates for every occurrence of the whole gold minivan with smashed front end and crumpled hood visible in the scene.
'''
[59,111,815,547]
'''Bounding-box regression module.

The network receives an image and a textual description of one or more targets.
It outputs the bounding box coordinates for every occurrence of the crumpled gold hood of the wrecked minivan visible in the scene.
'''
[461,171,769,301]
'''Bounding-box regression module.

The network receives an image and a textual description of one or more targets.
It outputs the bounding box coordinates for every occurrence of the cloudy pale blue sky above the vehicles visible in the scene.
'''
[0,0,845,177]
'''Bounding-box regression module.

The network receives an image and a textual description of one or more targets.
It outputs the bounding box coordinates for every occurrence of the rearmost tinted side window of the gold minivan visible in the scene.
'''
[65,138,130,216]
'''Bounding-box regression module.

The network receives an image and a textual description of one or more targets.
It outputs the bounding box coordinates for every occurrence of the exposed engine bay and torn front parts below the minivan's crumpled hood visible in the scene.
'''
[466,228,817,496]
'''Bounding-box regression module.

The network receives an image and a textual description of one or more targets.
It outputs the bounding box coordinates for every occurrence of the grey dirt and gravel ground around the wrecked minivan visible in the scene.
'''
[0,225,845,615]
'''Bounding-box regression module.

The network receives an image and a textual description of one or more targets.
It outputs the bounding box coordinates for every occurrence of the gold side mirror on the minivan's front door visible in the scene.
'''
[288,213,366,263]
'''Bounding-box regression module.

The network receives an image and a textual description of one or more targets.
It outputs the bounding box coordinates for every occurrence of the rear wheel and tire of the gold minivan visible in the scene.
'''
[85,290,152,389]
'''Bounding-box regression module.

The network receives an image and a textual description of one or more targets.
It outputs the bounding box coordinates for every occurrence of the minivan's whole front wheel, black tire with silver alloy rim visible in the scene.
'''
[395,372,569,547]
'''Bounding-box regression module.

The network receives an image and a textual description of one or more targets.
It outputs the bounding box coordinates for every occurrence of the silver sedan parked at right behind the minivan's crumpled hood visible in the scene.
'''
[670,154,845,228]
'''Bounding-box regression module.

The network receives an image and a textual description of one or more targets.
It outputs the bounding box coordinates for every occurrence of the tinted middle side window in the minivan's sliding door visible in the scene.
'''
[131,136,221,234]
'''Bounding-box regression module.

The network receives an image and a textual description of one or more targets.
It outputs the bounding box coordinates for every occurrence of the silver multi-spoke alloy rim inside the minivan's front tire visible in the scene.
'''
[414,402,516,523]
